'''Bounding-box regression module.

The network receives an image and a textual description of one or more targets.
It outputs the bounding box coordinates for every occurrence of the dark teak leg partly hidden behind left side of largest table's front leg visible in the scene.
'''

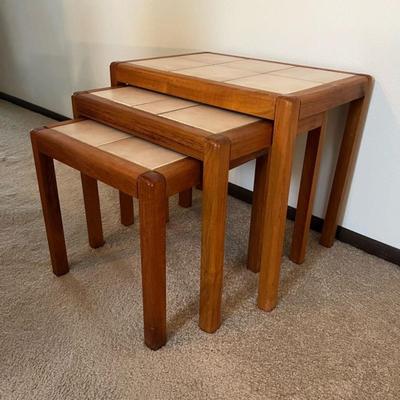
[247,154,268,272]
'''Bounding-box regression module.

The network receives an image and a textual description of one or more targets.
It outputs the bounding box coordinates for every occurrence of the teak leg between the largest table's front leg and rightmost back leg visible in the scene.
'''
[290,115,326,264]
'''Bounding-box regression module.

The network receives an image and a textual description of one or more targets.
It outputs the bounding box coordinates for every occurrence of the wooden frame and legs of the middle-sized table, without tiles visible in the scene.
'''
[72,81,324,332]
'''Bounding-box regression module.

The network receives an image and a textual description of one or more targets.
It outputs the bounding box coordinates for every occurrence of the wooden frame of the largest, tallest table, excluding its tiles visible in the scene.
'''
[110,53,372,318]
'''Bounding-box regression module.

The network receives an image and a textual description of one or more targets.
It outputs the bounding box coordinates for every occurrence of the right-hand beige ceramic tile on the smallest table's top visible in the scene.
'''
[99,136,186,169]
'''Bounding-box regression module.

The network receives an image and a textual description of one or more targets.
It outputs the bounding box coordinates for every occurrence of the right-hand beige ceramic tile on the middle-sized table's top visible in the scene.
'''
[162,106,258,133]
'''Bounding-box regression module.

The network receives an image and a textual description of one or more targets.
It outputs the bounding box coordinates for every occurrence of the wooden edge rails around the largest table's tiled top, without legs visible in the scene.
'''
[115,57,367,119]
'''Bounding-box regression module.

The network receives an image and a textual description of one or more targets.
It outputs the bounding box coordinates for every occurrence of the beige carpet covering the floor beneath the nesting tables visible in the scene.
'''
[0,97,400,400]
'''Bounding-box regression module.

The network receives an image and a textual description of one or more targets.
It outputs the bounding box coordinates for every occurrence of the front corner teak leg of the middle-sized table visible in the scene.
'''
[199,135,230,333]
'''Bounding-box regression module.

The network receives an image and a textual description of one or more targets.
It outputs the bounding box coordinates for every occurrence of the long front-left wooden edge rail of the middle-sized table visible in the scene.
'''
[74,93,212,159]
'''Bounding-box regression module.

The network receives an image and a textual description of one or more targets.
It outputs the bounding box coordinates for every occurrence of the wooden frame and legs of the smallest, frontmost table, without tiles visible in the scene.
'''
[31,120,201,350]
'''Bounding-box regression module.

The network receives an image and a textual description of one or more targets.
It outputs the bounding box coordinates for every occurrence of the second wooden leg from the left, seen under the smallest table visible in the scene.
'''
[81,173,104,249]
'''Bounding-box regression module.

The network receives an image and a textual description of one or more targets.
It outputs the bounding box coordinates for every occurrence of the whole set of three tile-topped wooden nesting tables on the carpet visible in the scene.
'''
[31,53,371,349]
